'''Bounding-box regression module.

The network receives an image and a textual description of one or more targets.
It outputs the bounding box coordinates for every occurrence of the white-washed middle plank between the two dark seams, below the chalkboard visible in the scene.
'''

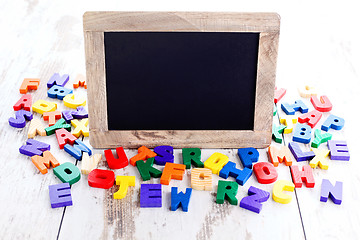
[60,146,303,239]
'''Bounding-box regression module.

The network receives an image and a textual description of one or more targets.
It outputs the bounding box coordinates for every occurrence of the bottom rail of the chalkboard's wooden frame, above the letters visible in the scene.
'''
[90,130,269,148]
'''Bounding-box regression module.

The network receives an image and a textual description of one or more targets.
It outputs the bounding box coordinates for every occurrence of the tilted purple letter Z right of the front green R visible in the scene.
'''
[240,186,270,213]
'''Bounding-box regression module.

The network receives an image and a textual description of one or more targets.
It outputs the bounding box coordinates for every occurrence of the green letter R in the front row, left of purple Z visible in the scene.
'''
[216,180,239,205]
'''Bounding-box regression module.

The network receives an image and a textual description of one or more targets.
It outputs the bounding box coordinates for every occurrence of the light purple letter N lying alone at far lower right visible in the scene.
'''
[320,179,343,205]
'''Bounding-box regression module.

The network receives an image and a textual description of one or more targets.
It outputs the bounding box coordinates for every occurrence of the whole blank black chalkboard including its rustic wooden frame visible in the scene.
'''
[84,12,280,148]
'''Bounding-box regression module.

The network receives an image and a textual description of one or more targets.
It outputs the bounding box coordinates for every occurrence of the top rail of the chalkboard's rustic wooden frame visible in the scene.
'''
[84,12,280,32]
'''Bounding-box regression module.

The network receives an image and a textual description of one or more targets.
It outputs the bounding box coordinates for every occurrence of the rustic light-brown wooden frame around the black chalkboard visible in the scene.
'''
[83,12,280,148]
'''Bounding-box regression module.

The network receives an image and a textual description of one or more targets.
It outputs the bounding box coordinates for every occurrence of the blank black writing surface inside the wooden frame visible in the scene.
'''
[104,32,259,130]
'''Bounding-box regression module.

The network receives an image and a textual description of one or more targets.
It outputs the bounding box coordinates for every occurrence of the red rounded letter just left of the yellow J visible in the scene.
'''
[88,169,115,189]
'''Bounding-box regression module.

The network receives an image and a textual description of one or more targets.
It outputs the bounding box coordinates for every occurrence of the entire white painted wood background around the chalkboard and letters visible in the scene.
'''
[0,0,360,239]
